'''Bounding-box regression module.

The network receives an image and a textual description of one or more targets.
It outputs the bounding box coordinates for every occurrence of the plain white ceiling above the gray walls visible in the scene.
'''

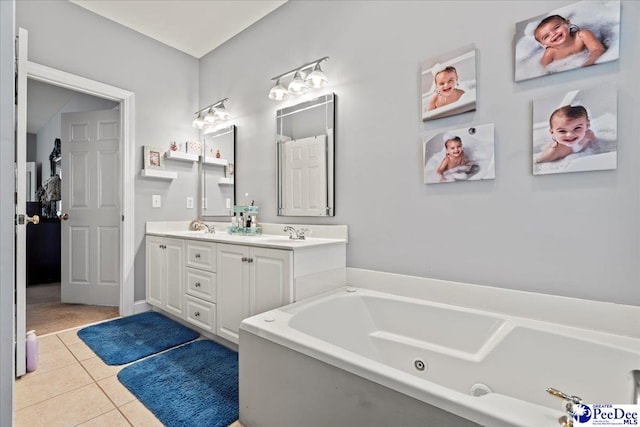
[69,0,286,58]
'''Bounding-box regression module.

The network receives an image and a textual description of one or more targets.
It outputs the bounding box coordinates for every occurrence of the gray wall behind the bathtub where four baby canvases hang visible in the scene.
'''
[200,1,640,305]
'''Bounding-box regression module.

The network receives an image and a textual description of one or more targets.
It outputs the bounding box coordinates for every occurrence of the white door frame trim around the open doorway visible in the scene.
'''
[26,61,136,316]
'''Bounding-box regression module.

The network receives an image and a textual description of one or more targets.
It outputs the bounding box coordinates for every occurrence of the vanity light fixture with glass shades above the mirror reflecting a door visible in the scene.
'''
[269,56,329,101]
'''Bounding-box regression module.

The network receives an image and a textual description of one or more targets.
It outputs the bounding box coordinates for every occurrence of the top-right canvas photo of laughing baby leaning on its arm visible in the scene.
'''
[514,0,620,81]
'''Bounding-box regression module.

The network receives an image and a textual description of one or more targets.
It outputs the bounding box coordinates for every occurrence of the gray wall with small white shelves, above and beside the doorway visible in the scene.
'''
[16,0,199,300]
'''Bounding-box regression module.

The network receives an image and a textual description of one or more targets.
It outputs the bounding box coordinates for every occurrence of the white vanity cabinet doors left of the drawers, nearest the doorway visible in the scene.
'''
[146,236,184,317]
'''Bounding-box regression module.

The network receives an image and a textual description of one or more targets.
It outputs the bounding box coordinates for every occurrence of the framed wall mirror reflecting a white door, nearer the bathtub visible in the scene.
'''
[276,93,336,216]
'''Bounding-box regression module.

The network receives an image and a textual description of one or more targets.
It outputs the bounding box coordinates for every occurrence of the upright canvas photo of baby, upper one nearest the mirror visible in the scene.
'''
[421,46,476,121]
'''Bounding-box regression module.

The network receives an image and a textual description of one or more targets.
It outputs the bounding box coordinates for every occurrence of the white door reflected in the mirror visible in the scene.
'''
[282,135,328,215]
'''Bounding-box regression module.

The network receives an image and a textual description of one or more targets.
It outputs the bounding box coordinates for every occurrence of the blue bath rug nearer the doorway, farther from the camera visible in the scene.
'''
[78,311,200,365]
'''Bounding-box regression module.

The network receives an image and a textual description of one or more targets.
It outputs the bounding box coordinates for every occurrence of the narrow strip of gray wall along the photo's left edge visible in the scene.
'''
[0,1,15,426]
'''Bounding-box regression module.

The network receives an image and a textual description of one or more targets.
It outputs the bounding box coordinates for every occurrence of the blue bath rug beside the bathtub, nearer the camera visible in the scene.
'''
[118,340,239,427]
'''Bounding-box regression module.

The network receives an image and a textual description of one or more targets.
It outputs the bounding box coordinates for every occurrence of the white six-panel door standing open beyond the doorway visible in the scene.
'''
[61,110,121,306]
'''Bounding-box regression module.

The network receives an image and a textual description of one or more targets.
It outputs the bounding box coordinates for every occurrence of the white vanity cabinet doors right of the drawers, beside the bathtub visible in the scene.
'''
[216,244,294,344]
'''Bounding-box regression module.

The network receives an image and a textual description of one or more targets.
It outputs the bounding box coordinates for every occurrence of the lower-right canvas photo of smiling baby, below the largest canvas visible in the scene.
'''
[533,86,618,175]
